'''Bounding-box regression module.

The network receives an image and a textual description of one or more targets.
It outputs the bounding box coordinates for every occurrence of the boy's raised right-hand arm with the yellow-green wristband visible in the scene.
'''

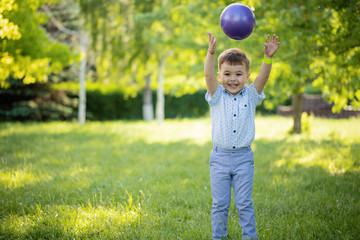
[254,34,280,94]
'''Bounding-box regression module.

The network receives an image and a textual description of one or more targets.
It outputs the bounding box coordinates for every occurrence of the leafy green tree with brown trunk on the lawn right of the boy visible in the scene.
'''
[256,0,360,133]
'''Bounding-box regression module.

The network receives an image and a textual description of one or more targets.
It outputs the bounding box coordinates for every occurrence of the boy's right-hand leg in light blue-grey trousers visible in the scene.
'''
[233,149,257,239]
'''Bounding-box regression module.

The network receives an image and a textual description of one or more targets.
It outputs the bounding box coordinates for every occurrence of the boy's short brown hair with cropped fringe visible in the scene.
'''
[218,48,250,72]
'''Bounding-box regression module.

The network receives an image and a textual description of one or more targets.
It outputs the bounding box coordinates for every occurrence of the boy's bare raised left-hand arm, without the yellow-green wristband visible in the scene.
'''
[204,32,219,96]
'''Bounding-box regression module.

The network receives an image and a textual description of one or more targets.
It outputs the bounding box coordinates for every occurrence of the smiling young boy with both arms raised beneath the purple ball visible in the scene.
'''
[204,33,280,239]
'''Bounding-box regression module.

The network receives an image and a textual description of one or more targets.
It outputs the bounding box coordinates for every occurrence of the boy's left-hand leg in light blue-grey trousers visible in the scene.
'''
[210,152,231,239]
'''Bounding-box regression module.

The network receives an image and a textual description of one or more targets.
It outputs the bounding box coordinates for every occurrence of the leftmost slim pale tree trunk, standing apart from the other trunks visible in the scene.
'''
[78,31,89,125]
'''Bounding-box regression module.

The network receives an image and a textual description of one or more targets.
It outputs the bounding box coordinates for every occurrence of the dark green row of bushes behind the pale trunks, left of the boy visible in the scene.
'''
[0,79,209,121]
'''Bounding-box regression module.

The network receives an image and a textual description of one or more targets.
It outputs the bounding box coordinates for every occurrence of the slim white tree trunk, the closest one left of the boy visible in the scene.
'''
[156,55,166,125]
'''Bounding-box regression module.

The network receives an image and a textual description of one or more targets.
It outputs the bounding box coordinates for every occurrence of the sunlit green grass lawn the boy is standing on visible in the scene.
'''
[0,116,360,239]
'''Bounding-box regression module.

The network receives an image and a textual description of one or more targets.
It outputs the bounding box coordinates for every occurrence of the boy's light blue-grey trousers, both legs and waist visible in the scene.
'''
[210,147,257,239]
